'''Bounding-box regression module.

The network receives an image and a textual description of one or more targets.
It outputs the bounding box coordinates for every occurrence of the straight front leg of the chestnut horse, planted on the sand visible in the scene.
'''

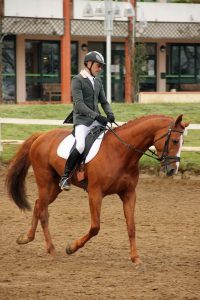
[119,190,141,264]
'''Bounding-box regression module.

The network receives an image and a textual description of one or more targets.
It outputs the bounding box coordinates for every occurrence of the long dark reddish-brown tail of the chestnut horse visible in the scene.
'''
[5,133,40,210]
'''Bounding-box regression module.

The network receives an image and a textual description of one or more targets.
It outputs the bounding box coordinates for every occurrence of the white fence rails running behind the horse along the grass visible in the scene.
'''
[0,118,200,152]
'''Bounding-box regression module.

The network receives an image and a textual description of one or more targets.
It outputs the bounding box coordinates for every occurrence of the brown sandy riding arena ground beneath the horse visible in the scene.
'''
[0,167,200,300]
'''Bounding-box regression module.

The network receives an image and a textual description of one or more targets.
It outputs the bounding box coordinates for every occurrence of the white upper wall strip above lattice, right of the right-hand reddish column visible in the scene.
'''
[137,2,200,22]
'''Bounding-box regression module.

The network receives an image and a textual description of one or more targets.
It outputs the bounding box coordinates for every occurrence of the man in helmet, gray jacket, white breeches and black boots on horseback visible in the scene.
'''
[59,51,115,190]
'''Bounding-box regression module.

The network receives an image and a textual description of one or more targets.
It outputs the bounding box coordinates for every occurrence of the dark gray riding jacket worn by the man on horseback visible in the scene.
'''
[72,74,112,126]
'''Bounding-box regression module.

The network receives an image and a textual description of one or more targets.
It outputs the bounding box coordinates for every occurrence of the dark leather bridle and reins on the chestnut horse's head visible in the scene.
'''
[107,123,184,167]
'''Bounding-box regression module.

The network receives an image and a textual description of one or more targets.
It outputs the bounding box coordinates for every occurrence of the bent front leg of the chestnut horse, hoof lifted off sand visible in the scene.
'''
[66,191,102,254]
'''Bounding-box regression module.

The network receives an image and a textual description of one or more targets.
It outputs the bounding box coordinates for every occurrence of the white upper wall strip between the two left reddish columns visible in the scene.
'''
[4,0,63,18]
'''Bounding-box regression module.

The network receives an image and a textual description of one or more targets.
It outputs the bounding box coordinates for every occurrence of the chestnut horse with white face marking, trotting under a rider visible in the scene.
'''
[6,115,189,265]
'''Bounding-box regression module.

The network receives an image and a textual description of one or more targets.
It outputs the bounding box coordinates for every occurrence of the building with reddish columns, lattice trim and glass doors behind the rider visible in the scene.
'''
[0,0,200,103]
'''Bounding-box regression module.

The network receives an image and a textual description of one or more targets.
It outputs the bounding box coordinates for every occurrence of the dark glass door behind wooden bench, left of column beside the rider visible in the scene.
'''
[26,41,60,101]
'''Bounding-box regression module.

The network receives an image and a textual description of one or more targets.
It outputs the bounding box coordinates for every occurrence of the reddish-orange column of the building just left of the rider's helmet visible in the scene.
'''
[61,0,71,103]
